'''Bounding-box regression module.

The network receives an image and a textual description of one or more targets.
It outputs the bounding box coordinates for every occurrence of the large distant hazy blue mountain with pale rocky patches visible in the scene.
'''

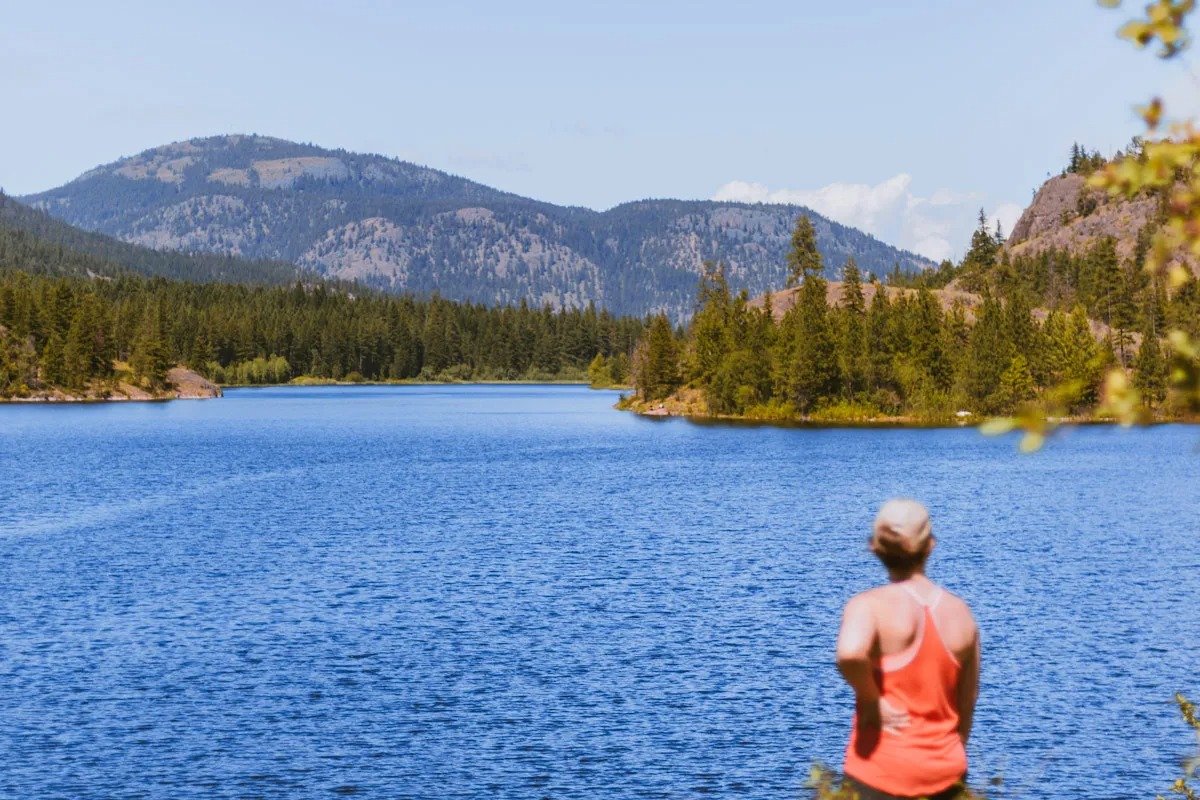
[23,136,931,319]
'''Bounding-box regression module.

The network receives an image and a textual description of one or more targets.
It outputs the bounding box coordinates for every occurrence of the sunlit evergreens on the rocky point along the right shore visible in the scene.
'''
[620,211,1200,423]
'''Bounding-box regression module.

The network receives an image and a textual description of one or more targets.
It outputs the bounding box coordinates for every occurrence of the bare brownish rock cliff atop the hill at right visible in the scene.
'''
[1007,175,1158,258]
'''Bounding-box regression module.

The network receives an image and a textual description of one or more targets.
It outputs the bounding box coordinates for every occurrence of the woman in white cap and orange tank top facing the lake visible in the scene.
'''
[838,500,979,800]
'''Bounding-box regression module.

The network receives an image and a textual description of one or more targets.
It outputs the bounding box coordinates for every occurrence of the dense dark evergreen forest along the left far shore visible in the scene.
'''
[0,271,646,399]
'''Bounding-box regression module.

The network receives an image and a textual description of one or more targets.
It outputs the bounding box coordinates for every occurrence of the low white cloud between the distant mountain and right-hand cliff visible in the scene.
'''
[713,173,1021,261]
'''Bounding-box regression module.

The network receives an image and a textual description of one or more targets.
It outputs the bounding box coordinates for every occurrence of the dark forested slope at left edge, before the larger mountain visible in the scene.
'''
[0,193,309,285]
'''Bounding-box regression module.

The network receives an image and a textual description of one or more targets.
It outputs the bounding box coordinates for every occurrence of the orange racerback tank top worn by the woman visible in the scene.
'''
[842,585,967,798]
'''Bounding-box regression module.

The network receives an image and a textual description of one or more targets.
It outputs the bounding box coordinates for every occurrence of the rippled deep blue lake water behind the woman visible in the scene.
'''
[0,386,1200,800]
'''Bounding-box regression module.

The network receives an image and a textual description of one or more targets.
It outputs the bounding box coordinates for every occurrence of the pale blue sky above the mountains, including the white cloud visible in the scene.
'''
[0,0,1200,259]
